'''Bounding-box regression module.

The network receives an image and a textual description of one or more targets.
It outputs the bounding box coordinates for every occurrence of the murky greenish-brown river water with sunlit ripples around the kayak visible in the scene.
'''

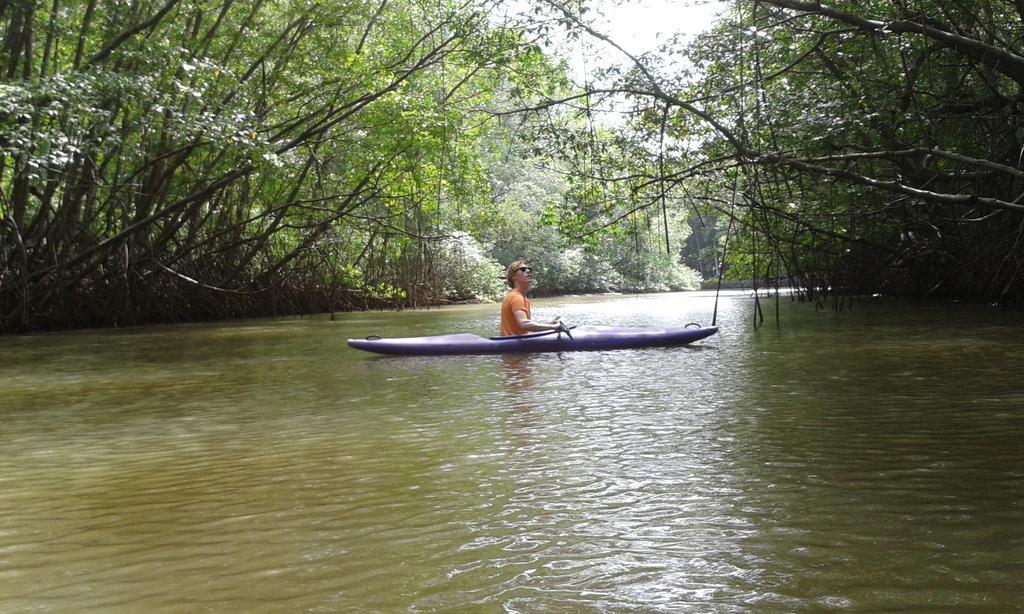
[0,293,1024,613]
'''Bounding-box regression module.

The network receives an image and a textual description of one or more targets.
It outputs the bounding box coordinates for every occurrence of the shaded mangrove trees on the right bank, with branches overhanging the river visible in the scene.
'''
[528,0,1024,303]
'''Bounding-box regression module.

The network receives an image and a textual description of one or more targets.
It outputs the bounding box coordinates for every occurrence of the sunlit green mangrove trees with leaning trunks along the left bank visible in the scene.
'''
[0,0,704,332]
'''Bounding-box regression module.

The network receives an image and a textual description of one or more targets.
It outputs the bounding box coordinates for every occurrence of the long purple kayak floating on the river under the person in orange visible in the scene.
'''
[348,325,718,356]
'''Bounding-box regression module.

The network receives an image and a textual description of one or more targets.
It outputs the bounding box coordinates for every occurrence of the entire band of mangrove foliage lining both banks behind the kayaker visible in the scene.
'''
[6,0,1024,332]
